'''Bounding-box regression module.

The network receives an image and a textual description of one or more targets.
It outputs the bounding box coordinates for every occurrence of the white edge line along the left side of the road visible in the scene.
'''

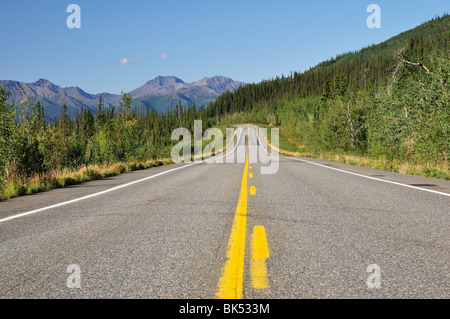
[0,130,246,223]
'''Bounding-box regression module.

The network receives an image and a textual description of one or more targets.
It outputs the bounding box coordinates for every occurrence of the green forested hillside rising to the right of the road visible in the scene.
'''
[206,15,450,172]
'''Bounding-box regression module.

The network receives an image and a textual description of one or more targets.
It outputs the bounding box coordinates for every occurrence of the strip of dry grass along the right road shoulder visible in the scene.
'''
[259,125,450,180]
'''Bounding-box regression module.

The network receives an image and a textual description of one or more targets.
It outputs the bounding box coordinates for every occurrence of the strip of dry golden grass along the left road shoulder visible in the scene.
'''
[0,158,172,200]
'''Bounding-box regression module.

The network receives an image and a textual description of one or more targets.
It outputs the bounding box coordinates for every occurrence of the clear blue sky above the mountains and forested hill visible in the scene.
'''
[0,0,450,93]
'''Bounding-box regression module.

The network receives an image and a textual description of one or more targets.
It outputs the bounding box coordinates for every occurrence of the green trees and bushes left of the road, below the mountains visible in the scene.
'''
[0,87,206,196]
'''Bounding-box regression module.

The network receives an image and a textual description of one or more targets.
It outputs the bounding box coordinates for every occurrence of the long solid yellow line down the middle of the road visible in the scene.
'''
[216,155,248,299]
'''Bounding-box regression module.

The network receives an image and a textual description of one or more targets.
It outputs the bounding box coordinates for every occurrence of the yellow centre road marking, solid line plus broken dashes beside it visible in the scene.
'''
[216,127,269,299]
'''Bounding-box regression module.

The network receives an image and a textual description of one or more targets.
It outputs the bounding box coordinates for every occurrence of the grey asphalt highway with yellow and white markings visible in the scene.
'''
[0,126,450,299]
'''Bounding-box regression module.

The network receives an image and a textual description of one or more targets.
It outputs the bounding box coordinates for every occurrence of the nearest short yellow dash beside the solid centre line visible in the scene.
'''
[250,226,269,289]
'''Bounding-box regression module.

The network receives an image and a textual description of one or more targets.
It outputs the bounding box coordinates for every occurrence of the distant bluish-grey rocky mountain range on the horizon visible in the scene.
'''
[0,76,245,118]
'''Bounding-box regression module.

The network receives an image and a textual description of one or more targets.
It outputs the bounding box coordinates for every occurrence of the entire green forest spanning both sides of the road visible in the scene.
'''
[0,15,450,198]
